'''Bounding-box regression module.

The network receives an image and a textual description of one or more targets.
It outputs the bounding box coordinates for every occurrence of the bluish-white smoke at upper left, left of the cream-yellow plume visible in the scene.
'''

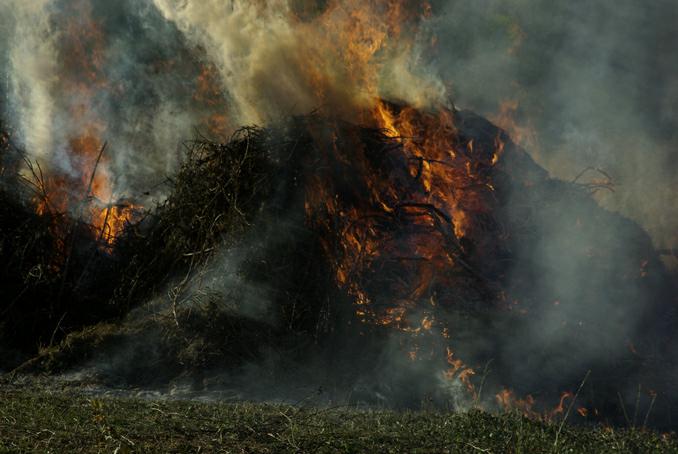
[0,0,234,203]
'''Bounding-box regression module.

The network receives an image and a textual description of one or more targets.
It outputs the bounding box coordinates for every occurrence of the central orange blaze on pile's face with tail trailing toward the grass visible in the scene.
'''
[305,99,503,397]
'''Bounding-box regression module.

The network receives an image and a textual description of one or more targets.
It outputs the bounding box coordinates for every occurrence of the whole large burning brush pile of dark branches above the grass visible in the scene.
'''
[0,101,675,420]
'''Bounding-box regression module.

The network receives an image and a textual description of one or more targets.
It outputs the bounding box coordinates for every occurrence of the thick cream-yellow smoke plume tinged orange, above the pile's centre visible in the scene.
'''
[150,0,444,124]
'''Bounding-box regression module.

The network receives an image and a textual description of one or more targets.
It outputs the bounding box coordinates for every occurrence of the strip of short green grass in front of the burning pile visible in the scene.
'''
[0,385,678,453]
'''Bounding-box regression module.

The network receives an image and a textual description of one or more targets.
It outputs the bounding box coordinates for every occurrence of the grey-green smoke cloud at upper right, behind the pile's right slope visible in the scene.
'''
[432,0,678,252]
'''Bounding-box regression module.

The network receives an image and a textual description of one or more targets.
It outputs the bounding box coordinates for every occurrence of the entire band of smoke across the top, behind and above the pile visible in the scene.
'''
[0,0,678,241]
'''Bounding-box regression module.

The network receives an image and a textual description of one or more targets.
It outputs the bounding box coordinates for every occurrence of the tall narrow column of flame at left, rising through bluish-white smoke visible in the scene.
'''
[29,0,139,250]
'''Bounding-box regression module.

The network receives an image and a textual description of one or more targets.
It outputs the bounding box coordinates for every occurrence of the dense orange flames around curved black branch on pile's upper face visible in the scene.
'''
[306,100,498,329]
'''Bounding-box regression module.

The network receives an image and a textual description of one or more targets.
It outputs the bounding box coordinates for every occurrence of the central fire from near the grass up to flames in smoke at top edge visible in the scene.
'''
[302,0,503,395]
